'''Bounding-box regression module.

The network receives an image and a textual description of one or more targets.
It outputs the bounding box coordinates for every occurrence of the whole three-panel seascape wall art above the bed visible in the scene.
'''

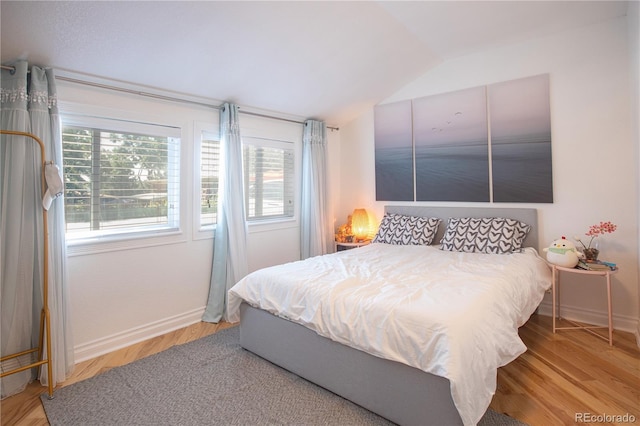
[375,74,553,203]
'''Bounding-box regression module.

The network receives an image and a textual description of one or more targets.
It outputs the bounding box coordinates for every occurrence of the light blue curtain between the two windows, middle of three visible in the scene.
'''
[202,103,248,323]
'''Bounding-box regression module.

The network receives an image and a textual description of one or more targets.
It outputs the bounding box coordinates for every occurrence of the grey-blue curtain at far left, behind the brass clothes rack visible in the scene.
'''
[0,61,74,398]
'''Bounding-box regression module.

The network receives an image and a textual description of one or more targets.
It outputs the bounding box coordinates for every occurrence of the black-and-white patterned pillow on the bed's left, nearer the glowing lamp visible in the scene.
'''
[373,213,440,246]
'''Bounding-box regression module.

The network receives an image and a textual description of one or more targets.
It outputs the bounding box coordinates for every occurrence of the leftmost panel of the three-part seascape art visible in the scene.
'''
[374,101,414,201]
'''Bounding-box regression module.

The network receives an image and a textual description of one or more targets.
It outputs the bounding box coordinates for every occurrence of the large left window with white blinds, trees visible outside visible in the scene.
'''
[62,117,180,240]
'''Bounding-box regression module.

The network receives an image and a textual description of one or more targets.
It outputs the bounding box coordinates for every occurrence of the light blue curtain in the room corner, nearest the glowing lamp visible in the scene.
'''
[300,120,328,259]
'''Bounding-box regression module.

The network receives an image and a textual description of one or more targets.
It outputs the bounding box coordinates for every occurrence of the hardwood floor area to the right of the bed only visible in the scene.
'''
[491,315,640,426]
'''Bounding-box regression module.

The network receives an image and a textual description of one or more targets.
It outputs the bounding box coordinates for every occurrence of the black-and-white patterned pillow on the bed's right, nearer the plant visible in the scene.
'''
[440,217,531,254]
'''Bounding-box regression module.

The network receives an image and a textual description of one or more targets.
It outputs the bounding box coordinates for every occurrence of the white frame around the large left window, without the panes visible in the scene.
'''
[59,102,188,256]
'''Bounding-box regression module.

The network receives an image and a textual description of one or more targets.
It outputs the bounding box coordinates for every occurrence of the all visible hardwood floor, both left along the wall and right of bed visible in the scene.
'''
[0,315,640,426]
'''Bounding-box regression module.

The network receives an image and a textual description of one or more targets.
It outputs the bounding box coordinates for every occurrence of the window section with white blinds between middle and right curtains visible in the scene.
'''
[243,138,295,221]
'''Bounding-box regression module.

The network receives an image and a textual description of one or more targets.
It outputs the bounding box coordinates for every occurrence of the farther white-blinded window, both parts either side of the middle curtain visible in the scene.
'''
[193,116,301,233]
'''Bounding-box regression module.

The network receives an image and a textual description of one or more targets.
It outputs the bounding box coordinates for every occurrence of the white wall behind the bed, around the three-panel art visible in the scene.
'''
[337,17,639,331]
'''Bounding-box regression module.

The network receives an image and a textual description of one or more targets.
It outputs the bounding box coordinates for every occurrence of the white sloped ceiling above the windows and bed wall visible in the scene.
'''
[0,0,627,125]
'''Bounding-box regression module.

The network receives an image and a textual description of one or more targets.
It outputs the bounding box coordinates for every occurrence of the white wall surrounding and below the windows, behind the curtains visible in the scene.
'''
[58,80,324,362]
